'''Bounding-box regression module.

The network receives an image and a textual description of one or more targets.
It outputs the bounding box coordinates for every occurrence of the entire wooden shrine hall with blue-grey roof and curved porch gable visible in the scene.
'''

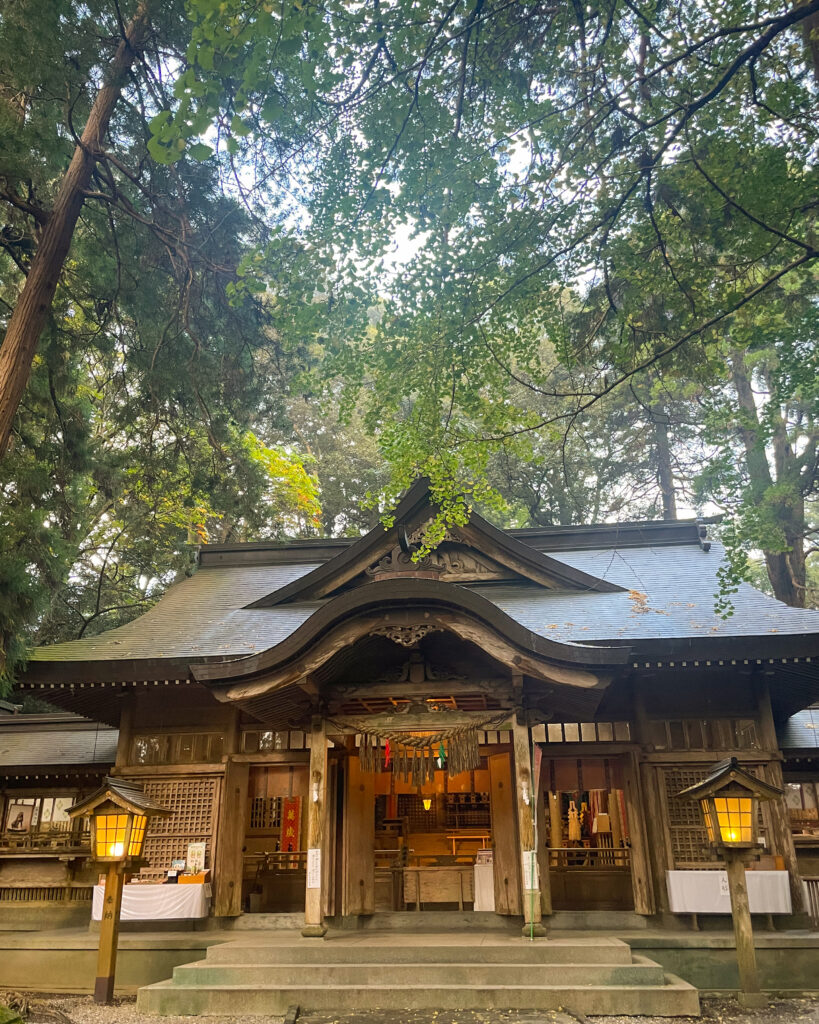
[21,481,819,935]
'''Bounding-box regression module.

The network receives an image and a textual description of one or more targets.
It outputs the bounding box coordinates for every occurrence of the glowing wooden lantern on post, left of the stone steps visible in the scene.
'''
[68,778,171,1004]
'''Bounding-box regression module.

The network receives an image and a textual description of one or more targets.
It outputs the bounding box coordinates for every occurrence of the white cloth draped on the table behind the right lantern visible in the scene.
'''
[665,870,790,913]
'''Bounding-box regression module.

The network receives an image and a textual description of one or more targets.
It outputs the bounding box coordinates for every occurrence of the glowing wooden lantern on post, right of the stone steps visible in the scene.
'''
[680,758,782,1007]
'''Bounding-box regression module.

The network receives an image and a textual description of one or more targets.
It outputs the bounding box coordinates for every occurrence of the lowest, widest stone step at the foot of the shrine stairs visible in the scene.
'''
[136,965,699,1018]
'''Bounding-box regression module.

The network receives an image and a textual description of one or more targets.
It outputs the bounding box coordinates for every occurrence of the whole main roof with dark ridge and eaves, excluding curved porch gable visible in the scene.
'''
[20,481,819,680]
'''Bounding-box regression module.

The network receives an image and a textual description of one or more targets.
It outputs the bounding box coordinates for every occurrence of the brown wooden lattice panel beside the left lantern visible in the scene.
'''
[133,778,219,870]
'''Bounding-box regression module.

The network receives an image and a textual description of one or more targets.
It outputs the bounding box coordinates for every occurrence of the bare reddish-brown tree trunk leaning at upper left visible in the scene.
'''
[0,0,147,458]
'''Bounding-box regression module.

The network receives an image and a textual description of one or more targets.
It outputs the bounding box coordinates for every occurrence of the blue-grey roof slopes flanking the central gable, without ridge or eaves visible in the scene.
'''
[32,539,819,662]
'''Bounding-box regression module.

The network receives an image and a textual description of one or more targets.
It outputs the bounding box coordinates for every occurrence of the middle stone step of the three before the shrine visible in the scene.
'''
[173,957,663,988]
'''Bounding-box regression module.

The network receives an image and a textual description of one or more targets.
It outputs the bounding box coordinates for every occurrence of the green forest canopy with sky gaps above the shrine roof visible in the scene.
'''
[0,0,819,685]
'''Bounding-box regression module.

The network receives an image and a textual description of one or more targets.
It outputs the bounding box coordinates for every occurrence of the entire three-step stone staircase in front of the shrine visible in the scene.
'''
[137,932,699,1017]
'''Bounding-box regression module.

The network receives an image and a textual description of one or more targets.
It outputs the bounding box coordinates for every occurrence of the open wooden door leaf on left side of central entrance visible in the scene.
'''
[342,748,376,916]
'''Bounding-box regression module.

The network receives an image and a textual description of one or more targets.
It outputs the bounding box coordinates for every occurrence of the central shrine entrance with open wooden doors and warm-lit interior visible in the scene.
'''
[335,729,521,918]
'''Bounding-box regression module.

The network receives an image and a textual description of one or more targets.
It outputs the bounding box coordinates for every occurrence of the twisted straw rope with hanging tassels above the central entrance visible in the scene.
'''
[334,711,510,785]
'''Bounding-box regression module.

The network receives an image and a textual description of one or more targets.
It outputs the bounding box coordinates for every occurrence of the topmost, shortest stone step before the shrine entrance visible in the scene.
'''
[207,933,632,965]
